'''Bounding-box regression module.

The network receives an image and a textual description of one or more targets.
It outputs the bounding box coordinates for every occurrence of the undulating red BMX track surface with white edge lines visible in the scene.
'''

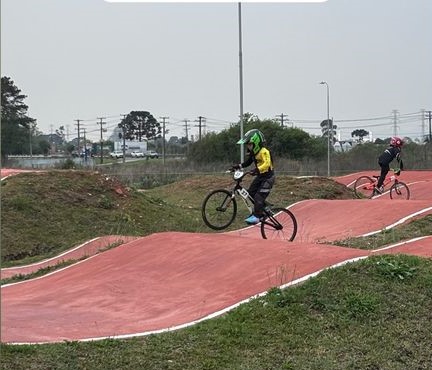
[1,170,432,343]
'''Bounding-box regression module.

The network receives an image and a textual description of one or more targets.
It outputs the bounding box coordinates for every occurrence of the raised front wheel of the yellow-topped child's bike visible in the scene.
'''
[201,189,237,230]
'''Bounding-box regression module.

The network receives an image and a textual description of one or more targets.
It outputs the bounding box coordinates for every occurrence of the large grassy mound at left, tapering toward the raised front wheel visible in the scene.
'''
[1,171,199,267]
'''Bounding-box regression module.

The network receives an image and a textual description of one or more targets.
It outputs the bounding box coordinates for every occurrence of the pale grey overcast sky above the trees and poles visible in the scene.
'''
[1,0,432,139]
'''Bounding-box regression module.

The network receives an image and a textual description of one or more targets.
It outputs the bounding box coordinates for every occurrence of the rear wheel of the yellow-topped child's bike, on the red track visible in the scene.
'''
[261,208,297,242]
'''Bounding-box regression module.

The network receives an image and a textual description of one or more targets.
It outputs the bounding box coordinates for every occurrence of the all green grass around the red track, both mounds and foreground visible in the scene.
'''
[0,171,432,370]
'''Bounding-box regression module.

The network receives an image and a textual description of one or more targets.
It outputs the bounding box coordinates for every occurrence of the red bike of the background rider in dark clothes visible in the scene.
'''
[354,168,410,199]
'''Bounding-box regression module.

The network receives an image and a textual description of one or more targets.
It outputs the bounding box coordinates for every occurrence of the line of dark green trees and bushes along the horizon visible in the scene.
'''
[1,77,430,171]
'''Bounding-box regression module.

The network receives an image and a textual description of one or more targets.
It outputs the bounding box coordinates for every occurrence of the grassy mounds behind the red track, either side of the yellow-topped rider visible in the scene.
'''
[1,171,353,267]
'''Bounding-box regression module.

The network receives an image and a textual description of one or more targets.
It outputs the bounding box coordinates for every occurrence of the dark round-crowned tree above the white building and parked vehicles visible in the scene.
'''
[119,111,162,141]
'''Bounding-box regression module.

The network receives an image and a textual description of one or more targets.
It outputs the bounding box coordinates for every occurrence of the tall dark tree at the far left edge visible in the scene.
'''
[1,76,36,162]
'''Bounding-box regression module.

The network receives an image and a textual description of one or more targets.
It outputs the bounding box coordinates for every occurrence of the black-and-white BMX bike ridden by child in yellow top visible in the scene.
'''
[201,170,297,241]
